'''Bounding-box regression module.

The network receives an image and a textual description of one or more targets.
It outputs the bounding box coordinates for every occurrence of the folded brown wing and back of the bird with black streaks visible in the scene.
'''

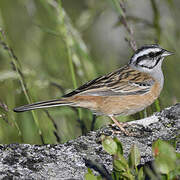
[64,66,154,97]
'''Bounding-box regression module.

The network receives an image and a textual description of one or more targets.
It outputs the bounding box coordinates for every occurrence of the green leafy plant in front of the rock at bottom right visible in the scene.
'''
[85,136,180,180]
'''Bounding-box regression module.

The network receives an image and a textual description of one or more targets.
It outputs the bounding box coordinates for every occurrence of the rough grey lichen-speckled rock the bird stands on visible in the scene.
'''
[0,103,180,179]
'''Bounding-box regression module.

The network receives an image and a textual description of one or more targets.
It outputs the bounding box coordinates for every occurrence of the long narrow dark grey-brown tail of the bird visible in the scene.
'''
[13,98,74,112]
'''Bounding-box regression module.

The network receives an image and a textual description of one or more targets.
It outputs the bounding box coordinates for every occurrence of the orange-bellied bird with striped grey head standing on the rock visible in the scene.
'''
[14,44,174,134]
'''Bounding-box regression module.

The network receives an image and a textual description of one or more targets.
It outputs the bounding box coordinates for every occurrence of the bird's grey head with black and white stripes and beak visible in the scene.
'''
[129,45,173,73]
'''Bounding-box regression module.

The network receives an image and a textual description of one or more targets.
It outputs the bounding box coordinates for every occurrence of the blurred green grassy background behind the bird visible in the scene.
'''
[0,0,180,144]
